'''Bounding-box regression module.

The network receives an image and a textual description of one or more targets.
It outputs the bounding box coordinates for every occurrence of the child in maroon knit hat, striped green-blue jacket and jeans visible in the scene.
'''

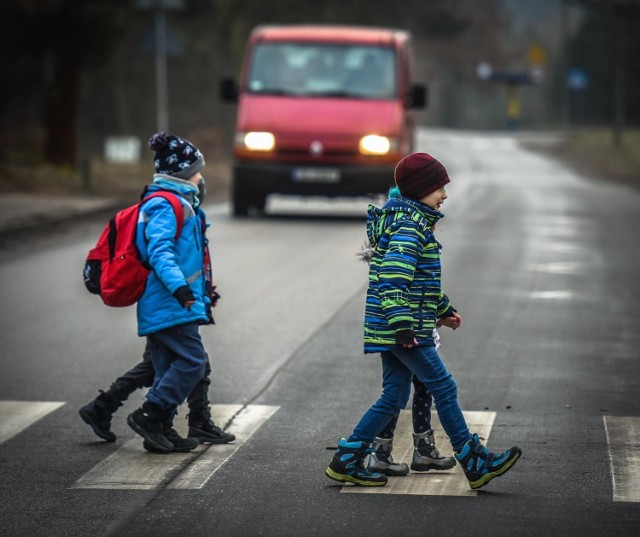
[325,153,521,489]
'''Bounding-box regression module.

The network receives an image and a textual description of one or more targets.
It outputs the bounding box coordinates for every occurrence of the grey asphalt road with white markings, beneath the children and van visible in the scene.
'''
[0,130,640,537]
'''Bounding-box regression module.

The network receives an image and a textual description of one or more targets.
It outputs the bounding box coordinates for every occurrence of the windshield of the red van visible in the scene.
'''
[247,43,397,99]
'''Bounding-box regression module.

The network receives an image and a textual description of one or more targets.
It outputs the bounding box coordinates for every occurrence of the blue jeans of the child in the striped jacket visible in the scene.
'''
[348,347,471,451]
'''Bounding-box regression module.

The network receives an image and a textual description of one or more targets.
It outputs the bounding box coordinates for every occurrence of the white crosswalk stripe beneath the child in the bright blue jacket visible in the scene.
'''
[71,405,279,490]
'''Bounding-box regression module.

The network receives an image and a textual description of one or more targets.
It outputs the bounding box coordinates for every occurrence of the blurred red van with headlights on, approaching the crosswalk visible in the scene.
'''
[221,25,426,216]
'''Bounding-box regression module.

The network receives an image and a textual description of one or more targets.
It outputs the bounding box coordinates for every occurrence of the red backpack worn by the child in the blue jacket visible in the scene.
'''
[84,192,184,307]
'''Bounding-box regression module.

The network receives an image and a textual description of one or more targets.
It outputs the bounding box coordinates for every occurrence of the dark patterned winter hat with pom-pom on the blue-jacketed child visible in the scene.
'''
[149,132,204,179]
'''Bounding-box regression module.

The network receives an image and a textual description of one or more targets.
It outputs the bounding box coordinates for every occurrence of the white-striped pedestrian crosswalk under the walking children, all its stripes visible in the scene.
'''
[0,401,640,503]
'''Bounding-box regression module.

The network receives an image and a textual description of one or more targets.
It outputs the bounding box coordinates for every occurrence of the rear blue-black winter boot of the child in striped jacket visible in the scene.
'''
[325,438,387,487]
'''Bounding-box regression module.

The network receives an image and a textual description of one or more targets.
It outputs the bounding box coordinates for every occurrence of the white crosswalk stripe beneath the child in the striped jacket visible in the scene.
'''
[341,410,496,496]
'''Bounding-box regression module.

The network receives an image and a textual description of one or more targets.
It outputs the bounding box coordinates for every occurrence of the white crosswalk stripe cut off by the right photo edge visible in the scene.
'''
[603,416,640,503]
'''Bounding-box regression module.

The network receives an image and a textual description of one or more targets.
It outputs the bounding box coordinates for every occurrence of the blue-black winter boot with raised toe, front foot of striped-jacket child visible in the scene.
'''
[455,434,522,489]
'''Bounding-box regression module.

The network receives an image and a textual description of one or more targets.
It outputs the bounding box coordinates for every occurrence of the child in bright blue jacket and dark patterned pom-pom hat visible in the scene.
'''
[127,132,221,452]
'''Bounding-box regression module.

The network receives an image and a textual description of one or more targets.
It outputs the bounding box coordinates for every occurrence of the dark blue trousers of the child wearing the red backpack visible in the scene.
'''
[147,323,207,408]
